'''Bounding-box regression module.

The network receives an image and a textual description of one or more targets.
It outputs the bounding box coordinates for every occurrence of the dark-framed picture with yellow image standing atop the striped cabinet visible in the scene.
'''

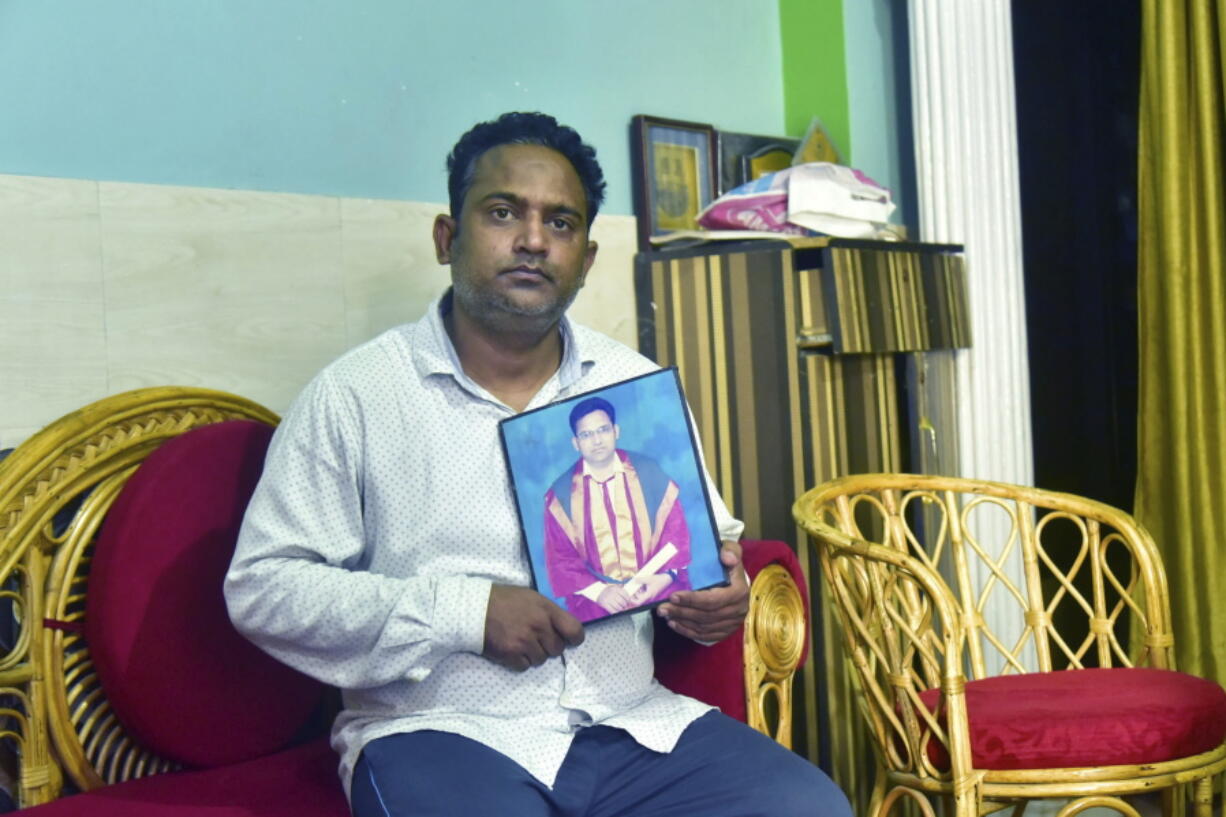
[630,115,718,251]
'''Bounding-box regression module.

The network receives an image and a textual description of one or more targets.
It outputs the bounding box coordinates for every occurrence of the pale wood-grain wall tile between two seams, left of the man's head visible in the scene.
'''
[99,183,346,411]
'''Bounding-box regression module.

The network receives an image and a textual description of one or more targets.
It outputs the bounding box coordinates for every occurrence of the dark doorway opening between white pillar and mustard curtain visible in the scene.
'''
[1013,0,1140,510]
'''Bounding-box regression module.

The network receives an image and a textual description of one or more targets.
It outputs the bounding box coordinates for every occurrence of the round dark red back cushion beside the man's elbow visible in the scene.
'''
[85,421,324,768]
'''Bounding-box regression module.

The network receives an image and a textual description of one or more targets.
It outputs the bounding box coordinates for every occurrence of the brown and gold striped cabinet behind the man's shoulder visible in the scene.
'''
[635,239,970,786]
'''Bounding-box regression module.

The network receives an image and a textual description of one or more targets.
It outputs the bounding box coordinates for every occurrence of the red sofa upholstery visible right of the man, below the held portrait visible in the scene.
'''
[655,540,809,721]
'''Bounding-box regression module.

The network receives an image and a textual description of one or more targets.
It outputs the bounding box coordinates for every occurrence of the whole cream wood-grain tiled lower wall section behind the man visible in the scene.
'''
[0,175,636,448]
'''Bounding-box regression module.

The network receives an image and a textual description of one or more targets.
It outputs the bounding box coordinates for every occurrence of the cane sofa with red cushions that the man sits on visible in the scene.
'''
[0,388,808,817]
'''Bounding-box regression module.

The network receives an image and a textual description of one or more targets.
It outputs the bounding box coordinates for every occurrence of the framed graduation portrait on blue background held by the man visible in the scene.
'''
[500,368,727,622]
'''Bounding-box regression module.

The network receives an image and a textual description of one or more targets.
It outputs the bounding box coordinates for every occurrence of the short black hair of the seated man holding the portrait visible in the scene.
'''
[447,113,604,228]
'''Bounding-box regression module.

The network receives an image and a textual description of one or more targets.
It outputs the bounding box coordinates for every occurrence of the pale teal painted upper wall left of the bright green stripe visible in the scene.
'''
[0,0,783,213]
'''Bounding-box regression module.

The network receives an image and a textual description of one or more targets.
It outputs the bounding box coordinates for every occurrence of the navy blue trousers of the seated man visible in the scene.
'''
[351,712,851,817]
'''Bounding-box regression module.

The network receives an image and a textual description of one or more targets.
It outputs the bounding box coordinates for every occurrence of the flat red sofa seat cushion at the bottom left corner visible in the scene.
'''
[21,740,349,817]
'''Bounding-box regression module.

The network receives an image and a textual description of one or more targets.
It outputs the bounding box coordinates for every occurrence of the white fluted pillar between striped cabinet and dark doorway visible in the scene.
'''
[910,0,1034,667]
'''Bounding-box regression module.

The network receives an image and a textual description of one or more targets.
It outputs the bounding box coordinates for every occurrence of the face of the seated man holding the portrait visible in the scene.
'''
[434,145,596,330]
